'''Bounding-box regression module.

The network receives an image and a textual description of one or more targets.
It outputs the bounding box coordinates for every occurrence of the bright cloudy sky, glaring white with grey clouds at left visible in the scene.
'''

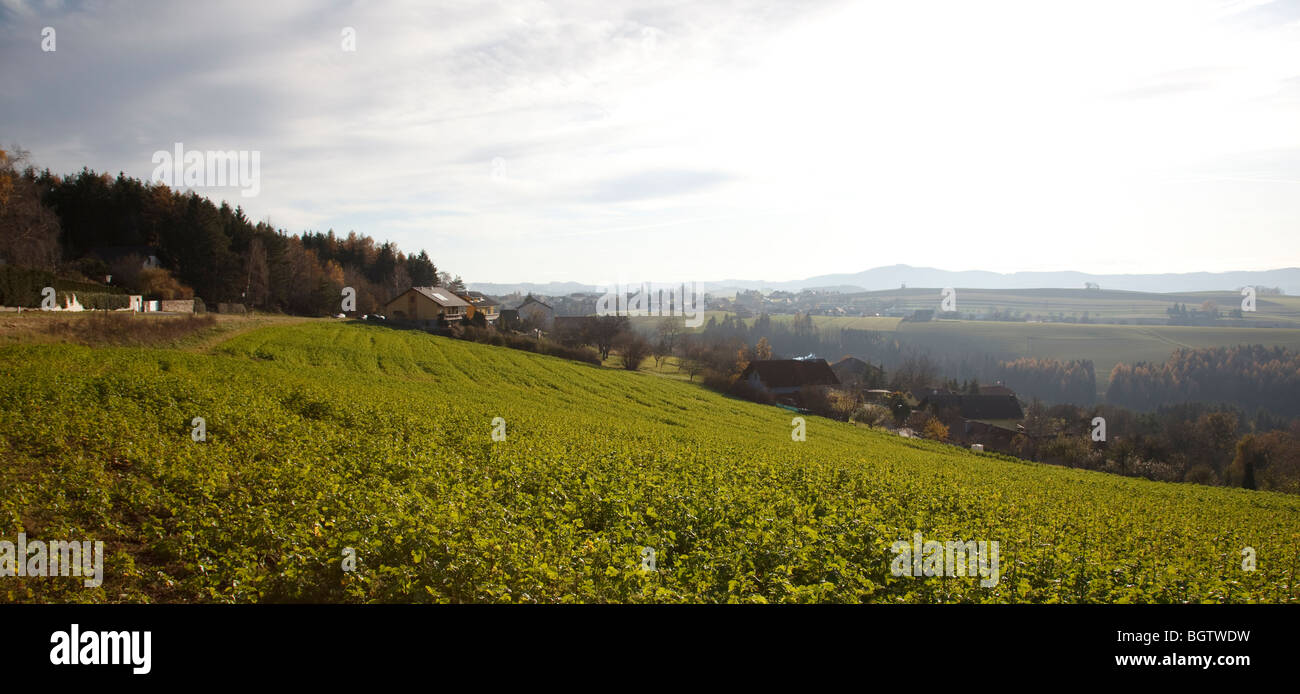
[0,0,1300,283]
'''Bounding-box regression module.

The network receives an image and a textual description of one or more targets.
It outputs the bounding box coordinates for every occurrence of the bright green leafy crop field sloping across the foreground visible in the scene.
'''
[0,321,1300,603]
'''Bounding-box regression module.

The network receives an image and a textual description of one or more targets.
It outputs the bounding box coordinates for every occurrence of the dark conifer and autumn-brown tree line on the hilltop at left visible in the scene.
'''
[0,151,444,316]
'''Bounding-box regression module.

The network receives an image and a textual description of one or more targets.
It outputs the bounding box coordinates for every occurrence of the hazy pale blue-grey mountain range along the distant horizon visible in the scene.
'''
[469,265,1300,296]
